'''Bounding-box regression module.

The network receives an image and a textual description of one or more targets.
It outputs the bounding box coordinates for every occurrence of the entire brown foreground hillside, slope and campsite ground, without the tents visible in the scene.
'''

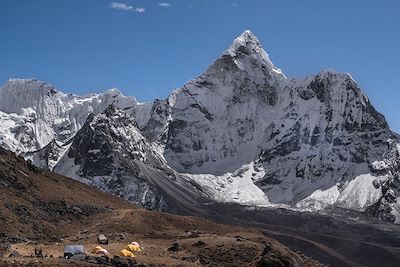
[0,149,320,266]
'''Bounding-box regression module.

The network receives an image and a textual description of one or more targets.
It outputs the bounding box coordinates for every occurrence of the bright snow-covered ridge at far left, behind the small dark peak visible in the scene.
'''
[0,79,137,153]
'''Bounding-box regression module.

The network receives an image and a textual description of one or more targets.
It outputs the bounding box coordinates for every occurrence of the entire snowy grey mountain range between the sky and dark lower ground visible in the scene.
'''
[0,31,400,224]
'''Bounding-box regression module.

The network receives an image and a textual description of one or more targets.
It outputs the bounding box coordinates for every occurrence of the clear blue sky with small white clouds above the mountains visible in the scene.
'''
[0,0,400,132]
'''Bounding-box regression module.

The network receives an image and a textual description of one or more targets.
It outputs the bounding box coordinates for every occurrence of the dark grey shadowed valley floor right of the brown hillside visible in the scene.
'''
[205,204,400,267]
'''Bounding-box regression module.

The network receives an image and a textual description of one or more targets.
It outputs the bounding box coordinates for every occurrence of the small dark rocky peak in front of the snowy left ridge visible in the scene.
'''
[54,105,202,211]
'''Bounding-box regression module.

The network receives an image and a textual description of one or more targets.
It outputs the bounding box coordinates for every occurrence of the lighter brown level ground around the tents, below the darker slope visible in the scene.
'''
[0,209,318,266]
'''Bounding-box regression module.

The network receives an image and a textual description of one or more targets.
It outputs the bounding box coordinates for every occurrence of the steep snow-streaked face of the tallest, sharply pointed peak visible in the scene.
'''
[165,31,286,174]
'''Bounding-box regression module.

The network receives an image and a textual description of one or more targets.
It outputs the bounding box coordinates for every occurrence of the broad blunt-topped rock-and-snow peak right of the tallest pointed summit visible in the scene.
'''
[255,72,396,207]
